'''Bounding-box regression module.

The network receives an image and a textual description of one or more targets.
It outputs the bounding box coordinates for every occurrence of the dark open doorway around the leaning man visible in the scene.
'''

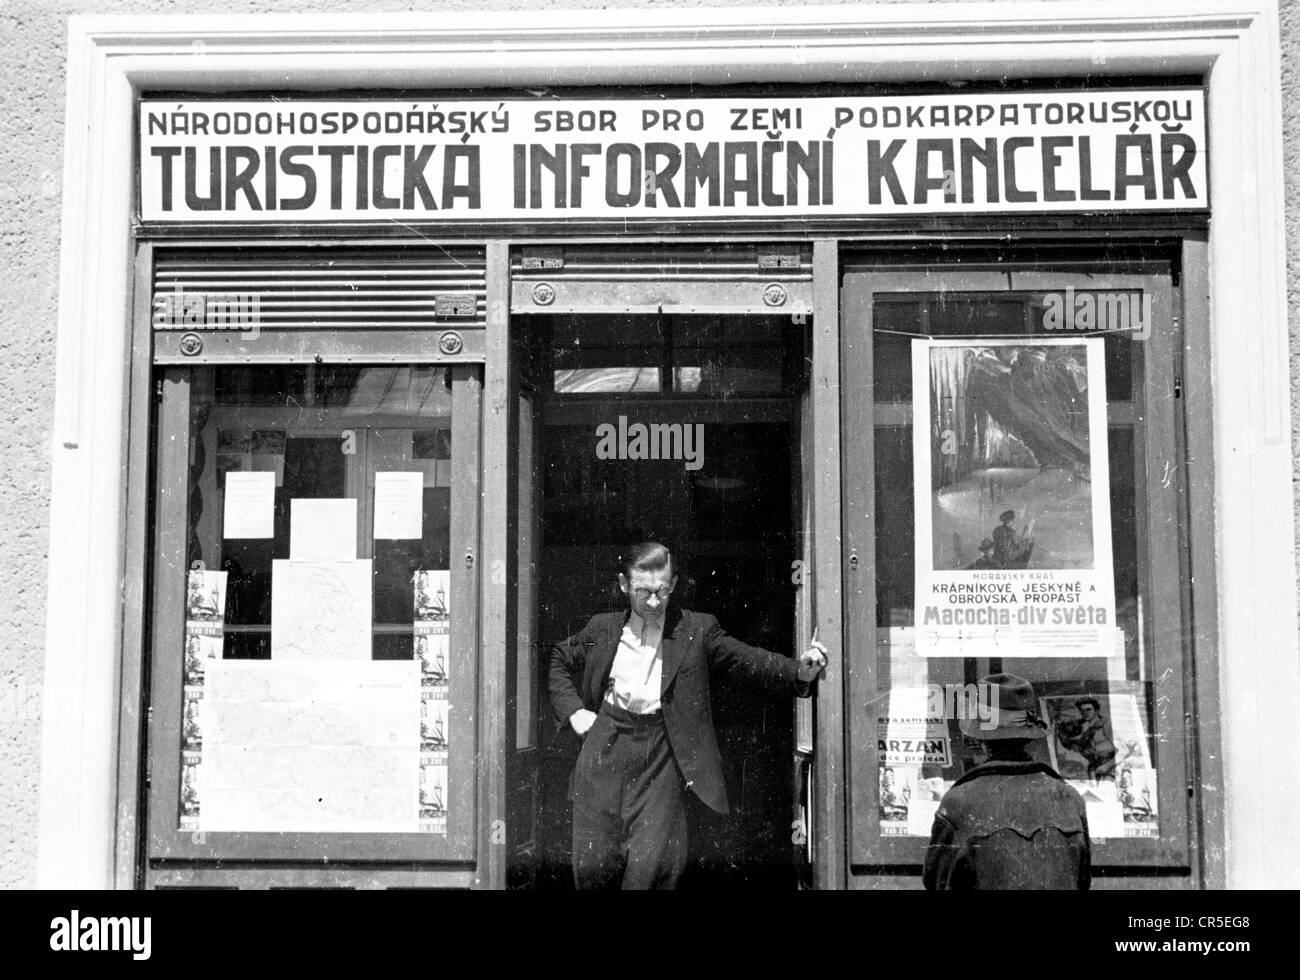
[523,315,807,888]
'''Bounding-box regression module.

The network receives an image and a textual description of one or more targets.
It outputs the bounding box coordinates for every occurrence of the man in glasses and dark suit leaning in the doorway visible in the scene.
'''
[550,542,826,889]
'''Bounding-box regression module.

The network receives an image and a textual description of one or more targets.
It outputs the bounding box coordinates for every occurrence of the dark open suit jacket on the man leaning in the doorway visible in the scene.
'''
[550,606,810,814]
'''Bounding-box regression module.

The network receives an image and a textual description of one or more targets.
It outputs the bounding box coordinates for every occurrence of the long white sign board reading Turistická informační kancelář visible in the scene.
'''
[139,88,1209,224]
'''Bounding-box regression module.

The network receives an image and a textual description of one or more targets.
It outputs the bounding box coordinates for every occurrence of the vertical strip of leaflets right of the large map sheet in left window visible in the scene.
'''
[413,569,451,834]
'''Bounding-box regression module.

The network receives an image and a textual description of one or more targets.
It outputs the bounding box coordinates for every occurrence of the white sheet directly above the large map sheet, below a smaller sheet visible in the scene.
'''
[270,558,374,657]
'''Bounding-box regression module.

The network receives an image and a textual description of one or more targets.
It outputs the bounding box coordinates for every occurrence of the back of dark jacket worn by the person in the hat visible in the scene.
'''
[924,762,1092,890]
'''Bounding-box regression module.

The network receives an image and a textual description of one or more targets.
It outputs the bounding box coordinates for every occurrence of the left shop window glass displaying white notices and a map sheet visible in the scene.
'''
[178,364,457,836]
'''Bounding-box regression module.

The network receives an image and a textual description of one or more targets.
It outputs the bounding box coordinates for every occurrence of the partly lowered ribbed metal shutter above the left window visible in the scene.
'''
[152,244,488,364]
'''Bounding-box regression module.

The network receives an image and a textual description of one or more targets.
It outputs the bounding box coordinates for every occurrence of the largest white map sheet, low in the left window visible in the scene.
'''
[199,660,420,833]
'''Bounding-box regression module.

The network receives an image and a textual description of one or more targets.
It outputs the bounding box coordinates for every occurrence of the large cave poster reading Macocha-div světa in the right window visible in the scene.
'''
[915,337,1115,658]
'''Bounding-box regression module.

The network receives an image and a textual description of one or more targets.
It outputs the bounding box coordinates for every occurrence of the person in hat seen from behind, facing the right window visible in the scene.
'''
[923,673,1092,890]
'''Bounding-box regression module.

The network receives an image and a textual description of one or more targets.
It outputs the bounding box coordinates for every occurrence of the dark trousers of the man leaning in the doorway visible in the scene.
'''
[573,703,686,889]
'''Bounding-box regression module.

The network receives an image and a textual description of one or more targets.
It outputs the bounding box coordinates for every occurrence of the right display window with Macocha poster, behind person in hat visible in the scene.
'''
[847,259,1184,863]
